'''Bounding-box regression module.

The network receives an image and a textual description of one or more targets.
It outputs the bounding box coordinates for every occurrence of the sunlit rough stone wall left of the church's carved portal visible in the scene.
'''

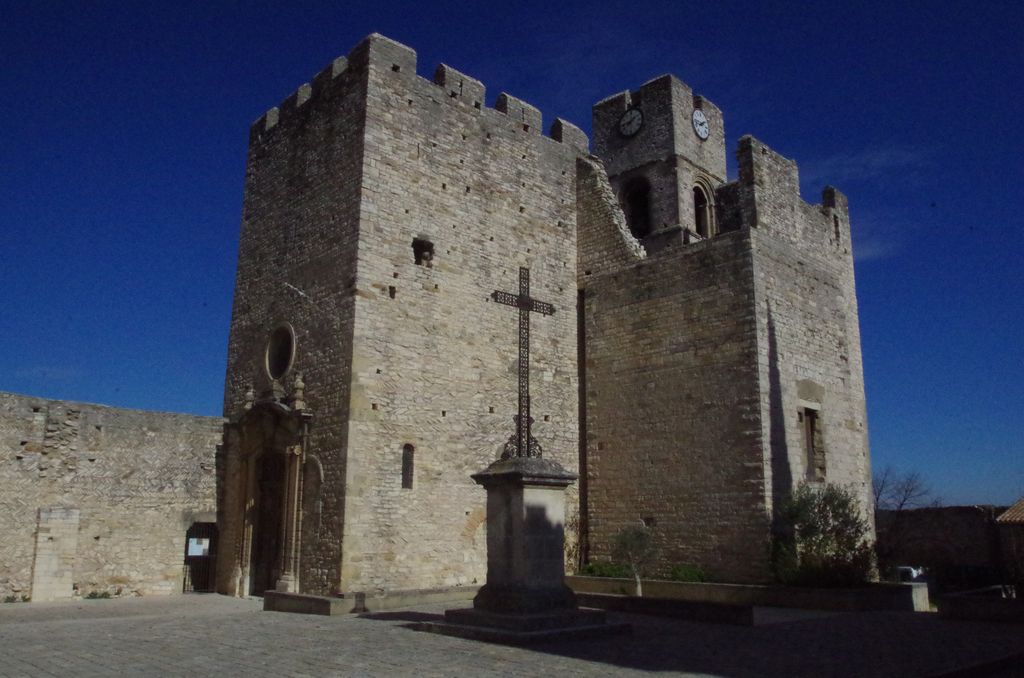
[0,393,221,600]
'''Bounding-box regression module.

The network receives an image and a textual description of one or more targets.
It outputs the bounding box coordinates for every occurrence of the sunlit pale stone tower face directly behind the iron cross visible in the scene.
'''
[342,37,586,591]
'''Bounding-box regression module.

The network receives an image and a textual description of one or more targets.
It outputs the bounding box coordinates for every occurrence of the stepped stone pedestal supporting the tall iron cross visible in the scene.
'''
[419,457,629,643]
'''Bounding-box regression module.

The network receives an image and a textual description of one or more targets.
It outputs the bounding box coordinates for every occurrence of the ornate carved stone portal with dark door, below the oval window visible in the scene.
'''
[233,400,312,596]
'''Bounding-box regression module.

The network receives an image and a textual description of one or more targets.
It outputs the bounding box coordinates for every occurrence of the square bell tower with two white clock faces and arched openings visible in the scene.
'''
[593,75,725,253]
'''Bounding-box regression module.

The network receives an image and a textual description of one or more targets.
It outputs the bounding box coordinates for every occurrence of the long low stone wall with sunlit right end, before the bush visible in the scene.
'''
[565,577,929,611]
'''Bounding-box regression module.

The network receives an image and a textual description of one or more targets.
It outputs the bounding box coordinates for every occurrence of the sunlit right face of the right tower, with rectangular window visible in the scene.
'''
[729,137,871,521]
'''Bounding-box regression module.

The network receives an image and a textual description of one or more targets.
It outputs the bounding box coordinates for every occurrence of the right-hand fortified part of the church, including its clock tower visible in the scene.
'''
[578,76,870,582]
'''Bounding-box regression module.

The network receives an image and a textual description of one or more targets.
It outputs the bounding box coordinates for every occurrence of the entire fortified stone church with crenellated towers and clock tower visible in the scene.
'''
[0,34,870,606]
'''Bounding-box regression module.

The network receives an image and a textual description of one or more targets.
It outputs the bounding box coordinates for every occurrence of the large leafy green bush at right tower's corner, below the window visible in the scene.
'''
[771,484,874,587]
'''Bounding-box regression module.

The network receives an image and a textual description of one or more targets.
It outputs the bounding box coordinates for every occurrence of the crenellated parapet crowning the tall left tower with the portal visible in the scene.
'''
[249,33,590,154]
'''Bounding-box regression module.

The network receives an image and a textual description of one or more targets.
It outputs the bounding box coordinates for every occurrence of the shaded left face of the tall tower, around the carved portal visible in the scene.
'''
[217,42,367,595]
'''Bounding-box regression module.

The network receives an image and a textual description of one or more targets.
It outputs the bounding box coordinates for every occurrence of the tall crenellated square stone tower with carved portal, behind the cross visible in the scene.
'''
[218,35,588,595]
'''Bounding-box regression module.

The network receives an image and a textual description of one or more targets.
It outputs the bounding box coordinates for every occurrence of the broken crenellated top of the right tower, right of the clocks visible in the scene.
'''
[733,134,850,255]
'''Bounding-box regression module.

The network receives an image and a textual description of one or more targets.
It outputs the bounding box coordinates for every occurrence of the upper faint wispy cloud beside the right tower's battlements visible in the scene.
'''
[800,145,930,185]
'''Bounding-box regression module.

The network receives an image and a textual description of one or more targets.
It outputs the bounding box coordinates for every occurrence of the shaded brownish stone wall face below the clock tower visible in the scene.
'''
[585,231,768,582]
